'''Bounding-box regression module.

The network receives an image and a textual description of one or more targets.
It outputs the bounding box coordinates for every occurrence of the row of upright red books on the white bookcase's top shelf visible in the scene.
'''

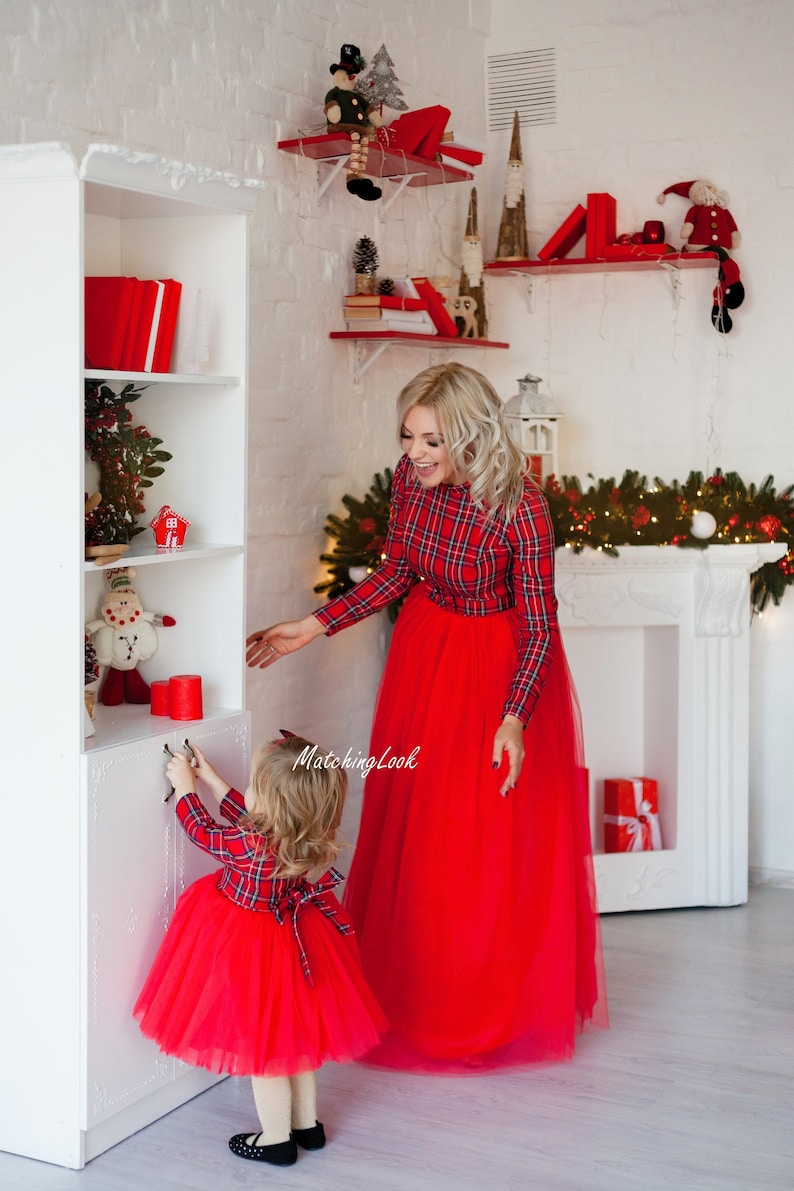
[85,276,182,373]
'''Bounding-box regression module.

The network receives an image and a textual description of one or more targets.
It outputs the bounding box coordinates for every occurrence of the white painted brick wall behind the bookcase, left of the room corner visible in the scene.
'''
[0,0,489,838]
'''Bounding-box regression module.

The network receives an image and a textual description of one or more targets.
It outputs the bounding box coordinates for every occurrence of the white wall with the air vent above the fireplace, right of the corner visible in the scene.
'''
[484,0,794,873]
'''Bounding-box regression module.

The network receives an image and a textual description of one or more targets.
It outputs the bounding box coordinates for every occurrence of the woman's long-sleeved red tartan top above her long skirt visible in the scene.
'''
[314,455,558,724]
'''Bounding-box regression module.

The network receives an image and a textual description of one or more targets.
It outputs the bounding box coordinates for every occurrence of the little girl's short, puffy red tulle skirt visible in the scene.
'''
[133,873,387,1075]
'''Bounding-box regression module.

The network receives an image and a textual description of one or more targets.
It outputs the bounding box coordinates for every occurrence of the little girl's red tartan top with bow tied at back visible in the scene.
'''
[176,790,352,984]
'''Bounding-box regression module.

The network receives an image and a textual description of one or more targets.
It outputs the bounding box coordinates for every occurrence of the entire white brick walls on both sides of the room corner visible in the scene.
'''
[0,0,794,871]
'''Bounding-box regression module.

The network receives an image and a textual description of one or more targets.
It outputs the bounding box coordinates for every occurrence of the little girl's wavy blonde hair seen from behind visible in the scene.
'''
[248,736,348,877]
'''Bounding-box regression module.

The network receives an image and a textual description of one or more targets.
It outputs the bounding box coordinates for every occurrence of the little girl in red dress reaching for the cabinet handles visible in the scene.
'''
[133,735,386,1166]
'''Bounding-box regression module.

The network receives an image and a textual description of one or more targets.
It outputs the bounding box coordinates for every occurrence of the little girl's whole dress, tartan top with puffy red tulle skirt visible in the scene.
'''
[133,790,387,1075]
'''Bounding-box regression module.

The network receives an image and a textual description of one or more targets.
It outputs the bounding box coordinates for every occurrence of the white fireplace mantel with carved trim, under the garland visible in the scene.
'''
[557,542,787,912]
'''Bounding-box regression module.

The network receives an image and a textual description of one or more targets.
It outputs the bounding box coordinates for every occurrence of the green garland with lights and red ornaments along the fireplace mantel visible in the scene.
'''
[314,468,794,619]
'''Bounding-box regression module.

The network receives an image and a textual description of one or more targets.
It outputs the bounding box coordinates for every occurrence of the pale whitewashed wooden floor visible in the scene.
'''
[0,887,794,1191]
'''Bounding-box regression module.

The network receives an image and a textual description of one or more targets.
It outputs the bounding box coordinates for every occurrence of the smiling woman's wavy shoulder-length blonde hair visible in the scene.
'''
[396,363,527,520]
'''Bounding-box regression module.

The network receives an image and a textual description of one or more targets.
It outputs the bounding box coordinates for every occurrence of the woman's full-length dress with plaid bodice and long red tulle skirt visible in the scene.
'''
[314,456,607,1073]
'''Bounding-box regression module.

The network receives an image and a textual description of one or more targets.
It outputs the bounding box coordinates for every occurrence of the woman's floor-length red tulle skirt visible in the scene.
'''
[343,584,607,1074]
